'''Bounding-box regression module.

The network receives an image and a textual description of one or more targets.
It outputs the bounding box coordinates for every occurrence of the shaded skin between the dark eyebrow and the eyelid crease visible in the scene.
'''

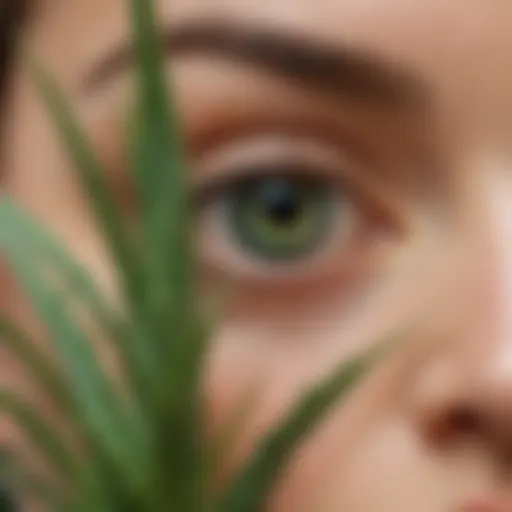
[170,58,411,164]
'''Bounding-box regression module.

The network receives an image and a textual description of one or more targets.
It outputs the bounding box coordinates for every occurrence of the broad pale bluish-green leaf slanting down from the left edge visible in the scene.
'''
[0,243,146,496]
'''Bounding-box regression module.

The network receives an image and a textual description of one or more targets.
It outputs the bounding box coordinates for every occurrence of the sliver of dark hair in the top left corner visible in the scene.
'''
[0,0,28,99]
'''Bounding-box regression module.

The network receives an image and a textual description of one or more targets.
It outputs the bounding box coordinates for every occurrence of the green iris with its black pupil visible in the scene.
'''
[225,177,338,261]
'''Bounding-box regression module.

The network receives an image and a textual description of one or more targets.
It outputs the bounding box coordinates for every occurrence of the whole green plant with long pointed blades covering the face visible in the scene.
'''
[0,0,388,512]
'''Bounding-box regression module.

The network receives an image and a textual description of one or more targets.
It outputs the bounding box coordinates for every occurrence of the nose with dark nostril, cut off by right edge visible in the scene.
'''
[416,168,512,460]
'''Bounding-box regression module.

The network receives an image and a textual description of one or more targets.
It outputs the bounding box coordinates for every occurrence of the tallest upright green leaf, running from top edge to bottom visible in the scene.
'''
[130,0,206,510]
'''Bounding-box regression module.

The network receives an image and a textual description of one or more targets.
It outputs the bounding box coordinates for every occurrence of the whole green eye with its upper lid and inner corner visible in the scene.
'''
[196,133,399,285]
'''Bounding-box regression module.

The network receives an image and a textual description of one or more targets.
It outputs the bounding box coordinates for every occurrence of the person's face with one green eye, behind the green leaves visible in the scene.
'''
[0,0,512,512]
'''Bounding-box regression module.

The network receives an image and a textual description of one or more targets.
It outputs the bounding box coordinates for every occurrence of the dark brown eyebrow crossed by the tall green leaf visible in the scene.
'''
[83,20,426,109]
